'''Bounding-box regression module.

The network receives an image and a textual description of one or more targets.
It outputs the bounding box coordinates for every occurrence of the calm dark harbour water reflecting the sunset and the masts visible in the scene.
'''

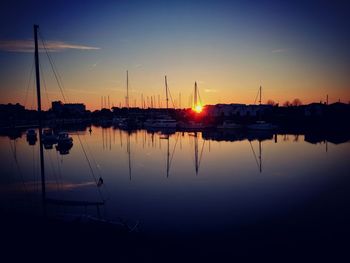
[0,127,350,262]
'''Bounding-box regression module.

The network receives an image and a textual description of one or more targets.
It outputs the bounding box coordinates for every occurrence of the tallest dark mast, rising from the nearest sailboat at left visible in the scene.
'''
[34,25,46,205]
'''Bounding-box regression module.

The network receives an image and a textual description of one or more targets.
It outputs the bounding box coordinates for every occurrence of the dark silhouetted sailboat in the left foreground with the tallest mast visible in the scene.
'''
[34,25,138,231]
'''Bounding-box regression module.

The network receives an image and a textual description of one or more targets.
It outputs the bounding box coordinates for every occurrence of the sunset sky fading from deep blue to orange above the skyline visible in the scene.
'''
[0,0,350,110]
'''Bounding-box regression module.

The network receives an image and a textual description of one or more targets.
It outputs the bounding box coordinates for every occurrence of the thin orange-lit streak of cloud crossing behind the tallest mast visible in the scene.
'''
[0,40,100,52]
